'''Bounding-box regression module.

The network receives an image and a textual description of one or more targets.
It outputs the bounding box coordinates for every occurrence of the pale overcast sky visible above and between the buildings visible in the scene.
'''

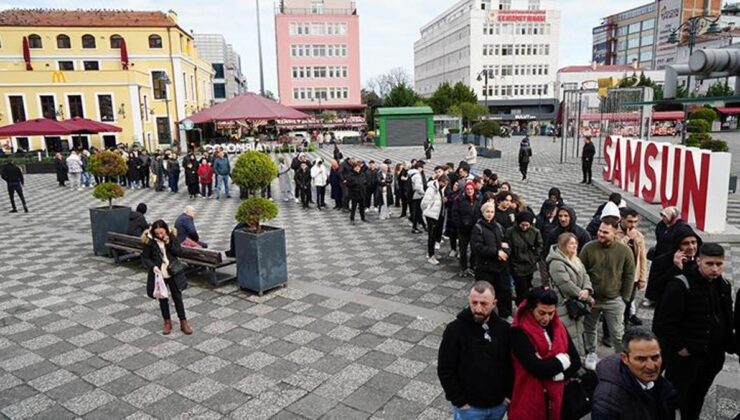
[0,0,650,92]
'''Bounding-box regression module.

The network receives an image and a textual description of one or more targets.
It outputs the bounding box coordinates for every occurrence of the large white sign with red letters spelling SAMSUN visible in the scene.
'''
[602,136,731,233]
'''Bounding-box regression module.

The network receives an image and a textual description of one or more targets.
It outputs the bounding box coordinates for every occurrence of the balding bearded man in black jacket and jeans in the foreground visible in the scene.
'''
[437,281,513,419]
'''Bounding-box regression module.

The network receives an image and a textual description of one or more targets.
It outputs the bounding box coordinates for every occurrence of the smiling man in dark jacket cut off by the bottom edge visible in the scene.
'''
[591,328,676,420]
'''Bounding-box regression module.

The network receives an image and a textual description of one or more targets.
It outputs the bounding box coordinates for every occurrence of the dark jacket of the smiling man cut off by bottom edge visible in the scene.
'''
[591,354,676,420]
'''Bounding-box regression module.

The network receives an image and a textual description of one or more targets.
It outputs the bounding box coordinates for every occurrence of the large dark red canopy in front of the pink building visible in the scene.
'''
[187,92,310,124]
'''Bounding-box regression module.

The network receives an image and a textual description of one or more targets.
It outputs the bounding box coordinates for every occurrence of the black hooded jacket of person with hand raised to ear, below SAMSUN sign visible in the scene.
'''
[645,222,704,302]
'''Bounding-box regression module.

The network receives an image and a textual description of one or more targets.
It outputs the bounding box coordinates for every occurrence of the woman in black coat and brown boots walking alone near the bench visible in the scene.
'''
[141,219,193,335]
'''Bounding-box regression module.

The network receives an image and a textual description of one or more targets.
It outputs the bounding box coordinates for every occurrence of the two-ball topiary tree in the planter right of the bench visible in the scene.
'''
[231,150,278,233]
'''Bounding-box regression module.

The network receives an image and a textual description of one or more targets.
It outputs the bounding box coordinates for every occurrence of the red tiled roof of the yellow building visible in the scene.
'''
[0,9,177,28]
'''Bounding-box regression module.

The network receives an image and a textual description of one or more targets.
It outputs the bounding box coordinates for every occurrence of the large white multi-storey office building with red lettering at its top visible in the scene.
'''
[414,0,560,121]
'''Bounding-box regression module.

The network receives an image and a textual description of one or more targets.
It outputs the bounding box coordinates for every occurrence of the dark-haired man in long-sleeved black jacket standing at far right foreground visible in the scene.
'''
[653,243,735,420]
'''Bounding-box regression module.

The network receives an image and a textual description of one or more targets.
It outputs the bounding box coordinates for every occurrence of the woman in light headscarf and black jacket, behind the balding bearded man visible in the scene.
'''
[470,203,512,319]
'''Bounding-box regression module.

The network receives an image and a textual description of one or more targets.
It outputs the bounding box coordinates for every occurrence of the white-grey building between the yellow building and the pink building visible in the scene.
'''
[193,34,247,103]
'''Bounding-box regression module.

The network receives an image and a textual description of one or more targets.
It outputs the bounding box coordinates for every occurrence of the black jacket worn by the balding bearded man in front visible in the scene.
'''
[437,308,513,408]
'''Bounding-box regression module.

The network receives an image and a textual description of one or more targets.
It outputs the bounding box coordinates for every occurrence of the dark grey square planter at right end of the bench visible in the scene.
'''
[234,225,288,296]
